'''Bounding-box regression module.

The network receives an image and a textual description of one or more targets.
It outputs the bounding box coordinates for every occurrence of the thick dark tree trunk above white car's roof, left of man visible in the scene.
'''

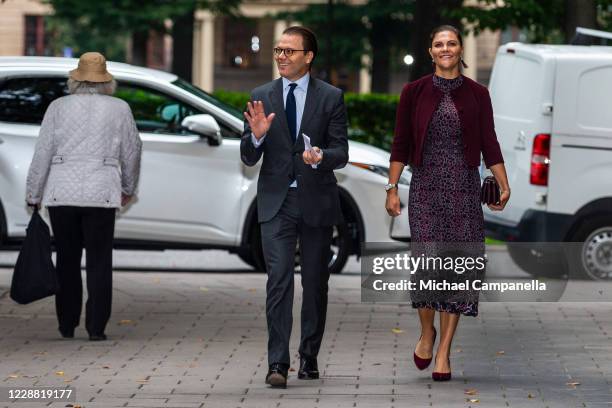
[172,9,195,82]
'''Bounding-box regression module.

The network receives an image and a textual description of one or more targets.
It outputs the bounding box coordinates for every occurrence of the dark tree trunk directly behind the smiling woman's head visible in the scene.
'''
[410,0,463,81]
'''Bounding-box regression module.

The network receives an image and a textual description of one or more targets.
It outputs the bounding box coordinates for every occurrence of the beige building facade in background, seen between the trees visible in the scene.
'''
[0,0,502,93]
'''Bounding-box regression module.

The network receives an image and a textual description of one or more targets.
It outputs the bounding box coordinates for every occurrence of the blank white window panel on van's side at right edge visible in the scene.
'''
[576,66,612,132]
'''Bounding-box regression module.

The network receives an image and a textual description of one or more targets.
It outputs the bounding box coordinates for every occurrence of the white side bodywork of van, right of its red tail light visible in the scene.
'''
[548,51,612,218]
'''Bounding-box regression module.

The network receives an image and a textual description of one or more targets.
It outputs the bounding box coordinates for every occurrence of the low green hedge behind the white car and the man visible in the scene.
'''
[213,91,399,151]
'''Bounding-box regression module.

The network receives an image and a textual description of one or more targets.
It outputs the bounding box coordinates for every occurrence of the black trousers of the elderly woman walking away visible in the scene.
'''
[49,206,115,335]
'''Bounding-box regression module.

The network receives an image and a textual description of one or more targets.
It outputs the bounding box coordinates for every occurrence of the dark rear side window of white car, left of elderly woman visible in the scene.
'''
[0,77,68,125]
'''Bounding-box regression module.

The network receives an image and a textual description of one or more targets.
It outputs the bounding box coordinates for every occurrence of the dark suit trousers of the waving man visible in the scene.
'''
[261,188,332,365]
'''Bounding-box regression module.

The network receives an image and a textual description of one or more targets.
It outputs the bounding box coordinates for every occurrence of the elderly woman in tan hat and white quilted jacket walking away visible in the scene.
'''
[26,52,142,341]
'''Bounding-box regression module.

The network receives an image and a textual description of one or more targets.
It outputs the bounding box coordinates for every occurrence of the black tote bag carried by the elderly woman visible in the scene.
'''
[11,208,58,305]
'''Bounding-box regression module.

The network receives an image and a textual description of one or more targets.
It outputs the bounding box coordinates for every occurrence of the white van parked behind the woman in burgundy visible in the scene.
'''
[485,43,612,280]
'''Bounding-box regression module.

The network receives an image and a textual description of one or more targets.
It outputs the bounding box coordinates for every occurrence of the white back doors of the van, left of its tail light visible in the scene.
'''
[484,43,555,227]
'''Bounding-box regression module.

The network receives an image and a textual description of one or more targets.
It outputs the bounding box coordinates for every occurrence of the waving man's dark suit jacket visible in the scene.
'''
[240,77,348,227]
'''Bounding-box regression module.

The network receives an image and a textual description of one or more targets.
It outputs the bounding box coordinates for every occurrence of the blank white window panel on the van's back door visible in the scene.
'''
[491,54,544,119]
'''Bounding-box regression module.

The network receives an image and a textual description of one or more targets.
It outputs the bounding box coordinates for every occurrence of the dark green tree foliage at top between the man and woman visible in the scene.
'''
[276,0,414,92]
